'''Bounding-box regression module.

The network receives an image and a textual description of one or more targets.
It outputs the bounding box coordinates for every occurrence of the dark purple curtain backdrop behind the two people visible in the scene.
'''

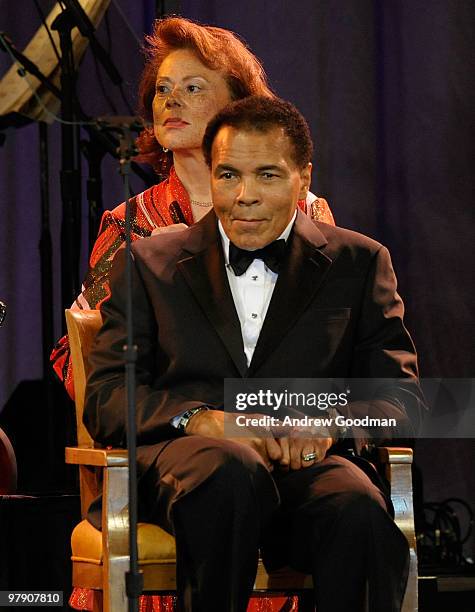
[0,0,475,568]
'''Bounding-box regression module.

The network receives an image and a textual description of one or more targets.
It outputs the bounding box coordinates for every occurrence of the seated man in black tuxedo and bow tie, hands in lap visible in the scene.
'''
[85,97,428,612]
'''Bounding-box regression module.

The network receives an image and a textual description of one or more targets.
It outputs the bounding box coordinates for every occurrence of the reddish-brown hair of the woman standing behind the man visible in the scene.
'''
[137,17,274,171]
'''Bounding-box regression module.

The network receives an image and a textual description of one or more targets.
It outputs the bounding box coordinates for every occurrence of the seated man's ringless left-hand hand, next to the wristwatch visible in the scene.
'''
[185,410,282,471]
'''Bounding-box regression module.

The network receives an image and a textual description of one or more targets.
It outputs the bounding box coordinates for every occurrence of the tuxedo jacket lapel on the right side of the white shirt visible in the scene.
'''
[247,211,332,376]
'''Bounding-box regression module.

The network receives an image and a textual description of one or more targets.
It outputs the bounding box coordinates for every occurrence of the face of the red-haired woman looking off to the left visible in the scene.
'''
[153,49,231,151]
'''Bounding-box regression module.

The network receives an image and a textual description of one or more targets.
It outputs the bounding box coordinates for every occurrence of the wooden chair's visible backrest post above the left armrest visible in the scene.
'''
[66,309,102,448]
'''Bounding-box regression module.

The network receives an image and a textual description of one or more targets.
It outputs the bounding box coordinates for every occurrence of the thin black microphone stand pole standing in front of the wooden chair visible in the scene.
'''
[114,117,143,612]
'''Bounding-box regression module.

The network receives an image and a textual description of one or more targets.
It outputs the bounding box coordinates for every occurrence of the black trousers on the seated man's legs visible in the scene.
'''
[139,436,409,612]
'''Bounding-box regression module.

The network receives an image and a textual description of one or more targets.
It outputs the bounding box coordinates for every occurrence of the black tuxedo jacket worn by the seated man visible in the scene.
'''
[84,212,422,469]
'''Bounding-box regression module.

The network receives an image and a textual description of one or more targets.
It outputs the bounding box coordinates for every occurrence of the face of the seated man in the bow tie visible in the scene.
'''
[211,126,312,250]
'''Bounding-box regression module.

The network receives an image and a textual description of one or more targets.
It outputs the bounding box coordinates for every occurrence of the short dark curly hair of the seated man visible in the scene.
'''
[203,96,313,169]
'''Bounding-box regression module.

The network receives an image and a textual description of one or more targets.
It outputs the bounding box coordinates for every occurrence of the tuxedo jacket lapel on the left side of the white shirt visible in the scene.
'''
[177,212,247,376]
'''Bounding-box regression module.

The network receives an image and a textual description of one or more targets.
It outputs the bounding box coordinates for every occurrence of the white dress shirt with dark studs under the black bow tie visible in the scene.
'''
[218,211,297,366]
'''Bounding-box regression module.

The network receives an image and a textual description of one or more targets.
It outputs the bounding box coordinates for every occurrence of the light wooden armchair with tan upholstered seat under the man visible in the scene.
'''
[66,310,417,612]
